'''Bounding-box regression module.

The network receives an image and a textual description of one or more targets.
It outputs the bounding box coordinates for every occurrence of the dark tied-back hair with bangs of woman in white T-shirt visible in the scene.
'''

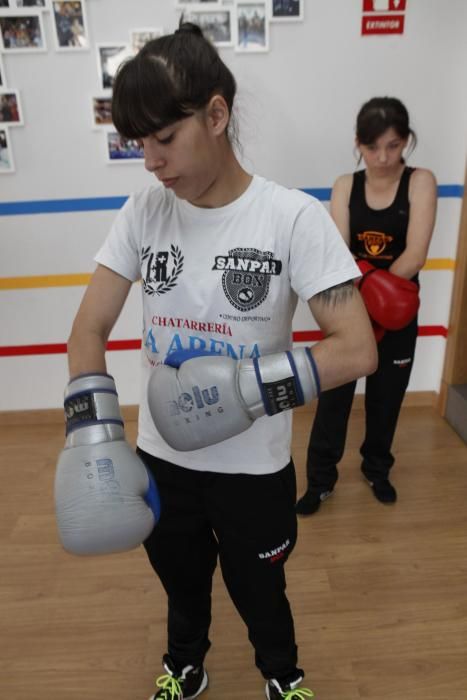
[112,21,237,139]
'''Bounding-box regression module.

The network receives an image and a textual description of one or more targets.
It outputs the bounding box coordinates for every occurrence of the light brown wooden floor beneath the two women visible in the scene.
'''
[0,406,467,700]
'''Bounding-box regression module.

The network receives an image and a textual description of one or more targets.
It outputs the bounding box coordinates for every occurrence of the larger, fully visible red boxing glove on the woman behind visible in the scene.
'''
[357,260,420,335]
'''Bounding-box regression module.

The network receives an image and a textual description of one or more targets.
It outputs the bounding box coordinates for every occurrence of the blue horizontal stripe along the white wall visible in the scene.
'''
[0,185,464,216]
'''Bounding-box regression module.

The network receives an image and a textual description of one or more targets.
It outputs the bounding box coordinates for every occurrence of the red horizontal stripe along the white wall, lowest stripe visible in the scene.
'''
[0,326,448,357]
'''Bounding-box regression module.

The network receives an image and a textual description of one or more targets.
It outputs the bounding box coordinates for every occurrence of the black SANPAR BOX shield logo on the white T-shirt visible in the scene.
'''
[212,248,282,311]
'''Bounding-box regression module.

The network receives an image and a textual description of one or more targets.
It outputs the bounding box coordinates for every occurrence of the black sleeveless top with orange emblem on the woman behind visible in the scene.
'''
[349,166,415,269]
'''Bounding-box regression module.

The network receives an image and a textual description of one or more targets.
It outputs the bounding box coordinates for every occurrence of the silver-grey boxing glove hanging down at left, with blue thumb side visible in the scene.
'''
[55,374,160,555]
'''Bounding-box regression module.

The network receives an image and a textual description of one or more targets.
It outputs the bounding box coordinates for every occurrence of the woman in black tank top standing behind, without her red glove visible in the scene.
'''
[296,97,437,515]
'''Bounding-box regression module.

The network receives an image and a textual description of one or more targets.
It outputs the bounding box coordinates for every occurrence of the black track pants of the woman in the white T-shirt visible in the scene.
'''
[138,449,297,679]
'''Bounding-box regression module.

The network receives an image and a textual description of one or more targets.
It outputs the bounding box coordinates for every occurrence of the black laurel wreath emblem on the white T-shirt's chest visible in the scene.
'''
[141,245,184,296]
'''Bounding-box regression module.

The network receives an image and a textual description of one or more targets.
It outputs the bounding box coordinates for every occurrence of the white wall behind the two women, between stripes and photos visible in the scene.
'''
[0,0,467,410]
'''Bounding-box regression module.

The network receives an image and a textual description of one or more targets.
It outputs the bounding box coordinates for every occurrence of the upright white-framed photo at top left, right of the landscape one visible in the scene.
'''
[52,0,89,51]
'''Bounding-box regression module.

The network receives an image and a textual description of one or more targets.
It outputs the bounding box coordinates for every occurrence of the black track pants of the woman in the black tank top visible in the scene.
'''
[307,320,418,491]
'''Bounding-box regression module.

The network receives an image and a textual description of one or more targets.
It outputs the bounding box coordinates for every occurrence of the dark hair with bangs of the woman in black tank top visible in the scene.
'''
[356,97,417,161]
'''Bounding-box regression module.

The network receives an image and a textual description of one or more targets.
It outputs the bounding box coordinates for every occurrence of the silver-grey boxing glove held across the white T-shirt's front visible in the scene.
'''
[148,348,319,452]
